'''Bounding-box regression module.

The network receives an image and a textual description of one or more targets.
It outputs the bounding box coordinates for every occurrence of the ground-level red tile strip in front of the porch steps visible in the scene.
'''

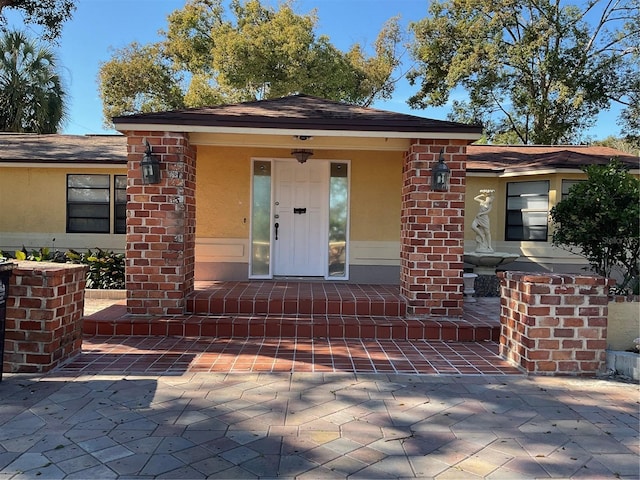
[57,336,521,375]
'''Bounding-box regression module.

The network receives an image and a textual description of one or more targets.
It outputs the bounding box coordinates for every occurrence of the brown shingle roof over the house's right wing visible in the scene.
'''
[467,145,640,172]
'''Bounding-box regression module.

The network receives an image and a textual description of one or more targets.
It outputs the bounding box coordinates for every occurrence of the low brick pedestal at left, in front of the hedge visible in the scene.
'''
[3,262,87,373]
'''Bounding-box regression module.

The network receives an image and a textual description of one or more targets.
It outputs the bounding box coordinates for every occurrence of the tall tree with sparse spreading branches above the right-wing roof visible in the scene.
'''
[408,0,640,144]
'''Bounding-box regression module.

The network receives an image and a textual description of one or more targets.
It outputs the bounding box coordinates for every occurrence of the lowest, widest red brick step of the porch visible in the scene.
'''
[83,305,500,342]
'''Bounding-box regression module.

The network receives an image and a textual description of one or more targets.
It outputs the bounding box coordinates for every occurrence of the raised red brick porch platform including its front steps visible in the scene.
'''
[83,282,500,342]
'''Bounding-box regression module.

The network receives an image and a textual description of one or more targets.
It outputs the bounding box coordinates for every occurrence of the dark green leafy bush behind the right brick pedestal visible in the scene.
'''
[551,160,640,291]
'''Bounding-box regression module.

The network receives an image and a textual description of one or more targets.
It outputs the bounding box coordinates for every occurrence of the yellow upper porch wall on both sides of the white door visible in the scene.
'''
[196,146,402,241]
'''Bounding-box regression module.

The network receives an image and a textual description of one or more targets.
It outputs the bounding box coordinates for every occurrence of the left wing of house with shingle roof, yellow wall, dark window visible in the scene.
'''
[0,133,127,254]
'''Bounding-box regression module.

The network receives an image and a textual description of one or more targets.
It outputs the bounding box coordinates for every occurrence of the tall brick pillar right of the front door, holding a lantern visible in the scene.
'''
[400,140,466,317]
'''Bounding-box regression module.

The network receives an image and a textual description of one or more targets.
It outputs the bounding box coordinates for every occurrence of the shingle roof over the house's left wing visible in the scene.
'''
[0,133,127,165]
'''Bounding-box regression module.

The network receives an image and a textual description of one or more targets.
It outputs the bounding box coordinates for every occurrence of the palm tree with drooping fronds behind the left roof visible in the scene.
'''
[0,32,66,133]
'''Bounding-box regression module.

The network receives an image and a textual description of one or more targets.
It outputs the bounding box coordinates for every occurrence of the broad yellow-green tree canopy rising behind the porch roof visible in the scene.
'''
[99,0,402,123]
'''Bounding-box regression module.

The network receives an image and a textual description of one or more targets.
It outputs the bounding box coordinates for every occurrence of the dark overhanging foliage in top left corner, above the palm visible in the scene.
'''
[0,0,76,40]
